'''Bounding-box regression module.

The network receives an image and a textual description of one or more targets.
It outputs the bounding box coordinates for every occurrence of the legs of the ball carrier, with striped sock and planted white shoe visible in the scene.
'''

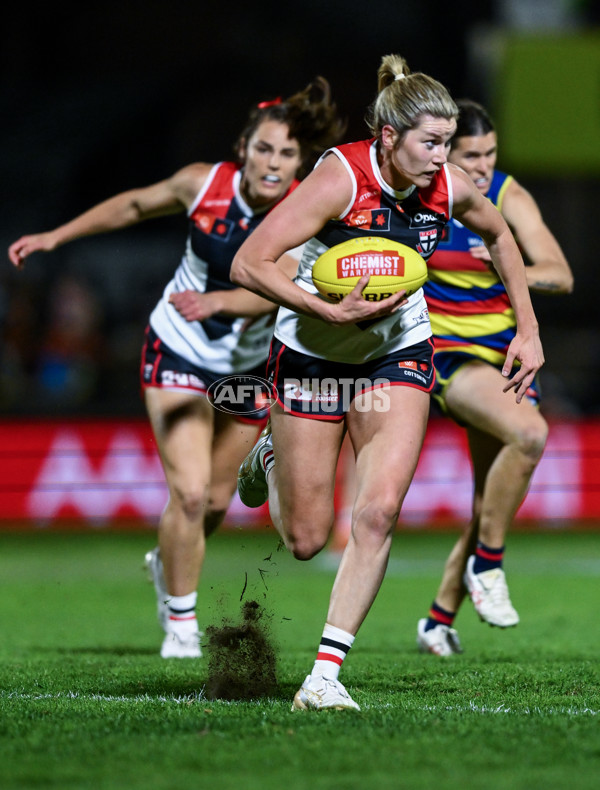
[284,386,429,710]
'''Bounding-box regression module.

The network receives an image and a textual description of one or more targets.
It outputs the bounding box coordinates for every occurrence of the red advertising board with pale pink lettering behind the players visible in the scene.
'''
[0,419,600,529]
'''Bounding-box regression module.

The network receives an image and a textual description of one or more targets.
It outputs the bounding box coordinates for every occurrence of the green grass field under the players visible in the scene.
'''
[0,530,600,790]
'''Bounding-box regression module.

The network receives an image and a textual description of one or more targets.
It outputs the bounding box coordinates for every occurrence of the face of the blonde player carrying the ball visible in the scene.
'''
[380,115,456,191]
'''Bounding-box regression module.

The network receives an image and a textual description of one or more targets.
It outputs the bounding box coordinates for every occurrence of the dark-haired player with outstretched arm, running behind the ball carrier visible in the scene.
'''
[9,77,345,658]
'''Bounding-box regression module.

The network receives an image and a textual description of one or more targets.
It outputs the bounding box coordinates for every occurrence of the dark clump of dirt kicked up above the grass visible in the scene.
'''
[203,601,277,700]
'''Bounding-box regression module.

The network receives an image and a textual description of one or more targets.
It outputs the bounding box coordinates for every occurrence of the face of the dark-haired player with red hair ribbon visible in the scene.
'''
[241,120,302,208]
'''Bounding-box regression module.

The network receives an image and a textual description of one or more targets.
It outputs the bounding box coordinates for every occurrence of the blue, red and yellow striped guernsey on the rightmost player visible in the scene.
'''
[423,170,516,372]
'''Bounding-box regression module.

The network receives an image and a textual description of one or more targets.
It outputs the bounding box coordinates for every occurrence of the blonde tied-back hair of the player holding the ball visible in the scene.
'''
[365,55,458,139]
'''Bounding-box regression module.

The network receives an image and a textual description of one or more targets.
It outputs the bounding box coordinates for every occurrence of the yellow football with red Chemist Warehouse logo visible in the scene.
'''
[312,236,427,302]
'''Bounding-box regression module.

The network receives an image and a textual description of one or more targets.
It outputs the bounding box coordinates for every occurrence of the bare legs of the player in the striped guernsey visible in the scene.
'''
[428,362,548,611]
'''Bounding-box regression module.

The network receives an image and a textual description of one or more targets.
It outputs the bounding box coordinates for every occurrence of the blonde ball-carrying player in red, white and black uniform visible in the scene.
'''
[231,55,543,709]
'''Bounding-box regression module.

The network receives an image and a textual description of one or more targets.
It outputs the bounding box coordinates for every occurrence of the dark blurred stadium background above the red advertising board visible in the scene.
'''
[0,0,600,417]
